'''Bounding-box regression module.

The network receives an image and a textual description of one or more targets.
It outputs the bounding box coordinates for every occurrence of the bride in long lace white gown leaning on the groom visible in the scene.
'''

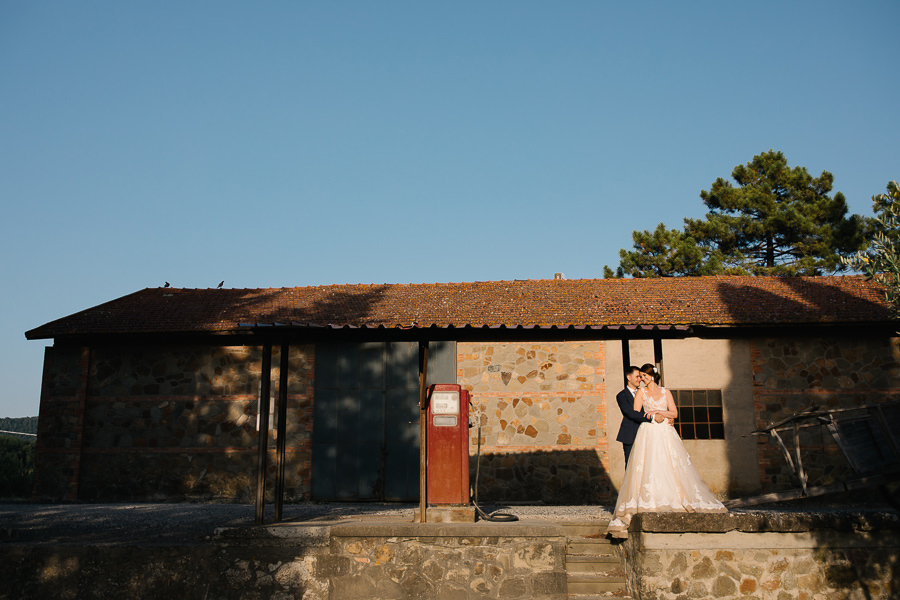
[607,364,727,538]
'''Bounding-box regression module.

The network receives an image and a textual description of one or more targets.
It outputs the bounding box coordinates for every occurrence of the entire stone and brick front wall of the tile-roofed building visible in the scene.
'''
[29,337,900,505]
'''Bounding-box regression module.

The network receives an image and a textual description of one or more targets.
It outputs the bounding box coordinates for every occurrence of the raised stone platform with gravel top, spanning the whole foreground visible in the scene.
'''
[0,505,900,600]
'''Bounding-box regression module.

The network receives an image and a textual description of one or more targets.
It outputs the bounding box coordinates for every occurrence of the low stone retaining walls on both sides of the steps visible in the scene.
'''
[0,511,900,600]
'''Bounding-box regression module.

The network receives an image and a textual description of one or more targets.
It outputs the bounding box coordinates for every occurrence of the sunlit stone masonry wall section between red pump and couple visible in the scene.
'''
[457,342,615,504]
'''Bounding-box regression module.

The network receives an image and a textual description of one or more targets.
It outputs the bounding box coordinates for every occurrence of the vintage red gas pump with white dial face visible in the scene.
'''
[425,383,475,523]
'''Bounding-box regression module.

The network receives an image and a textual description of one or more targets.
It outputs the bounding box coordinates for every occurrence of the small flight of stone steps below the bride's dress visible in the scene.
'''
[565,521,630,600]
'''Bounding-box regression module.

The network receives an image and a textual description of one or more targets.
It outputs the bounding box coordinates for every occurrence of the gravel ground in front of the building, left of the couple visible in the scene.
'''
[0,503,609,544]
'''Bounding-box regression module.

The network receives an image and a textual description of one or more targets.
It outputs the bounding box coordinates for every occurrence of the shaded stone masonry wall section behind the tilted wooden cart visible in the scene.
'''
[751,336,900,491]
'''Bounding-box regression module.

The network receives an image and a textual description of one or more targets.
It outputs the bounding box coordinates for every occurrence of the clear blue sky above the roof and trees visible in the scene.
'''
[0,0,900,417]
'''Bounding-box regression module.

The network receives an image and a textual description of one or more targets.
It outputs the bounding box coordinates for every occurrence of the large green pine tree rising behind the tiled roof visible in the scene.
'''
[603,150,873,277]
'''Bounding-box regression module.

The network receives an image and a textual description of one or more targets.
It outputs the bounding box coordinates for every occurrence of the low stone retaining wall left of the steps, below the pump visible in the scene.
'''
[0,522,566,600]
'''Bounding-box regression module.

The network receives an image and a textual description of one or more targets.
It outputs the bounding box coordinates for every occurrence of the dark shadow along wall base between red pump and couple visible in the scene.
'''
[469,450,616,505]
